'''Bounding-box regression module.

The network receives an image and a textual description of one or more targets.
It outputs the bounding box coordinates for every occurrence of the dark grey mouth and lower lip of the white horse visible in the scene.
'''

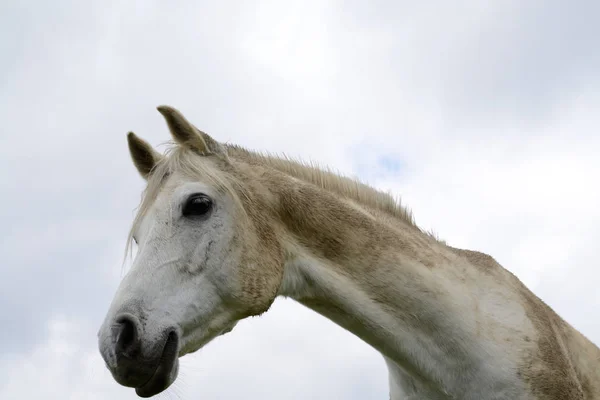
[135,332,179,398]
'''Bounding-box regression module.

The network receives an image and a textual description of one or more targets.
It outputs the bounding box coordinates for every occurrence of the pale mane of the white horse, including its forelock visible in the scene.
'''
[125,142,439,264]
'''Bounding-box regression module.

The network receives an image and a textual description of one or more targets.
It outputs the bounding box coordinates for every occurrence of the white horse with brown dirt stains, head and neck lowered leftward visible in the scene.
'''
[98,106,600,400]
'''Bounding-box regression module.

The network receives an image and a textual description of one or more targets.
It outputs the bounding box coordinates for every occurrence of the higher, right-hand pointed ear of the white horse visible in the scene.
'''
[157,106,224,155]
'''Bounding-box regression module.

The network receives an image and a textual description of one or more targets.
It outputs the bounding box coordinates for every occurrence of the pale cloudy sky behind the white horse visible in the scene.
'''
[0,0,600,400]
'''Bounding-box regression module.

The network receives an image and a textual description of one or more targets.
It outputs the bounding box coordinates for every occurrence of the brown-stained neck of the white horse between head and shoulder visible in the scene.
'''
[262,170,506,398]
